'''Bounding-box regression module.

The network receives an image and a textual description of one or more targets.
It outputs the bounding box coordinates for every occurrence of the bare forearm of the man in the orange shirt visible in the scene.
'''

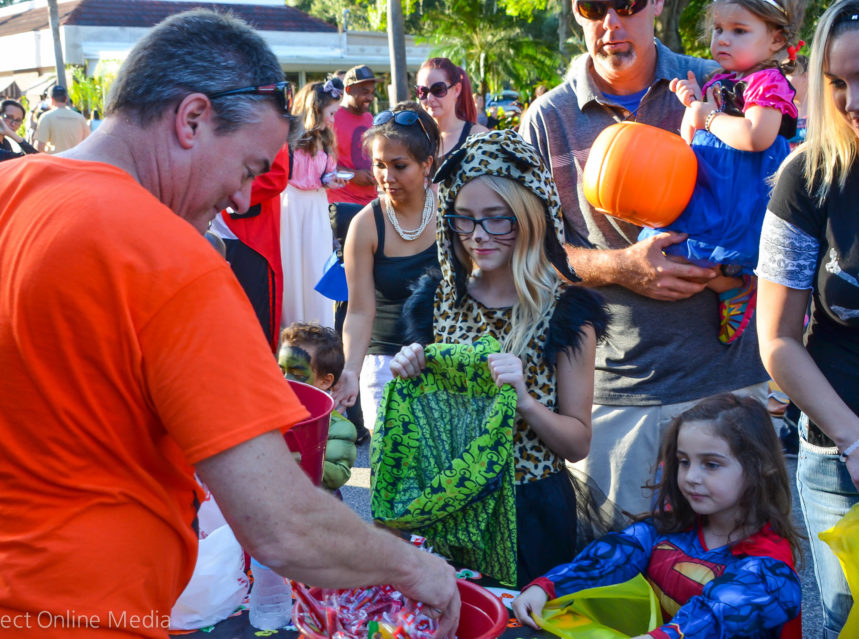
[197,431,419,588]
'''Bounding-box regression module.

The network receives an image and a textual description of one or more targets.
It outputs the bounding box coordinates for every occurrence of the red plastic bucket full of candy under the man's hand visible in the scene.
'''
[292,579,510,639]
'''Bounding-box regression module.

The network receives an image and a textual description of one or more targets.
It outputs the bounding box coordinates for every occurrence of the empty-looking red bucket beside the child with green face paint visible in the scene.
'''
[283,379,334,486]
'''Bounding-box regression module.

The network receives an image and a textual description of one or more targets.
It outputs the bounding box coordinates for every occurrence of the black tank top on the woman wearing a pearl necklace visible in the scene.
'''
[367,198,438,355]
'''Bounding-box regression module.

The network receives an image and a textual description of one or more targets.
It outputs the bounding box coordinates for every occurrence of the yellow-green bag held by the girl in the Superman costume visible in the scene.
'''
[535,575,662,639]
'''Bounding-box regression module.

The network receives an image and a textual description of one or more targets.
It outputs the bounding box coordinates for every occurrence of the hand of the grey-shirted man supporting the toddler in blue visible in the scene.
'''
[617,231,718,301]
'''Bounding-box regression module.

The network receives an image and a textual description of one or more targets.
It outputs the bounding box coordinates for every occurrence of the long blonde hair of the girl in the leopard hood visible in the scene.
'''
[457,175,561,357]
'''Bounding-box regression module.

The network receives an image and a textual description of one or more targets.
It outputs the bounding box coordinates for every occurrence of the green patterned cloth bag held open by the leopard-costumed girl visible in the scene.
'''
[370,337,517,584]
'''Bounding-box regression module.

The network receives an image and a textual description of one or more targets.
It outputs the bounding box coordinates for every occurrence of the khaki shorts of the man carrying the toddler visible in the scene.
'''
[568,382,767,515]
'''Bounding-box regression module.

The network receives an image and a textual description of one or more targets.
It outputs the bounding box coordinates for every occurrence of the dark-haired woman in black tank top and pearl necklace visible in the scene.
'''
[333,102,439,430]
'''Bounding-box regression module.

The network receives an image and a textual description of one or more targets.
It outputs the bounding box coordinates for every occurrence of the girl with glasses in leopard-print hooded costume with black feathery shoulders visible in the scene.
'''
[391,131,608,585]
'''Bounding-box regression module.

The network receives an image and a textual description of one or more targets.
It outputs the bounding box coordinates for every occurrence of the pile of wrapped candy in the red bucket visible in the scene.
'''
[298,585,438,639]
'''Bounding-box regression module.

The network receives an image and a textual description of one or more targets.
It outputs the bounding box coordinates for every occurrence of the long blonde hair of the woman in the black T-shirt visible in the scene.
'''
[800,0,859,204]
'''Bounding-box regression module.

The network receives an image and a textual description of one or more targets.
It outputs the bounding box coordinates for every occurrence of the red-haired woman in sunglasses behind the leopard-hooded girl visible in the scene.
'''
[415,58,489,162]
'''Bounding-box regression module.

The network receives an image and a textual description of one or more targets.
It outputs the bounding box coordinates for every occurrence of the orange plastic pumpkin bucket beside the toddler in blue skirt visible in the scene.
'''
[582,122,698,228]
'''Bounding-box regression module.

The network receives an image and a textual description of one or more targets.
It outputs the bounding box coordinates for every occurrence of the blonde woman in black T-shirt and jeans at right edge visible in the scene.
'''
[757,0,859,637]
